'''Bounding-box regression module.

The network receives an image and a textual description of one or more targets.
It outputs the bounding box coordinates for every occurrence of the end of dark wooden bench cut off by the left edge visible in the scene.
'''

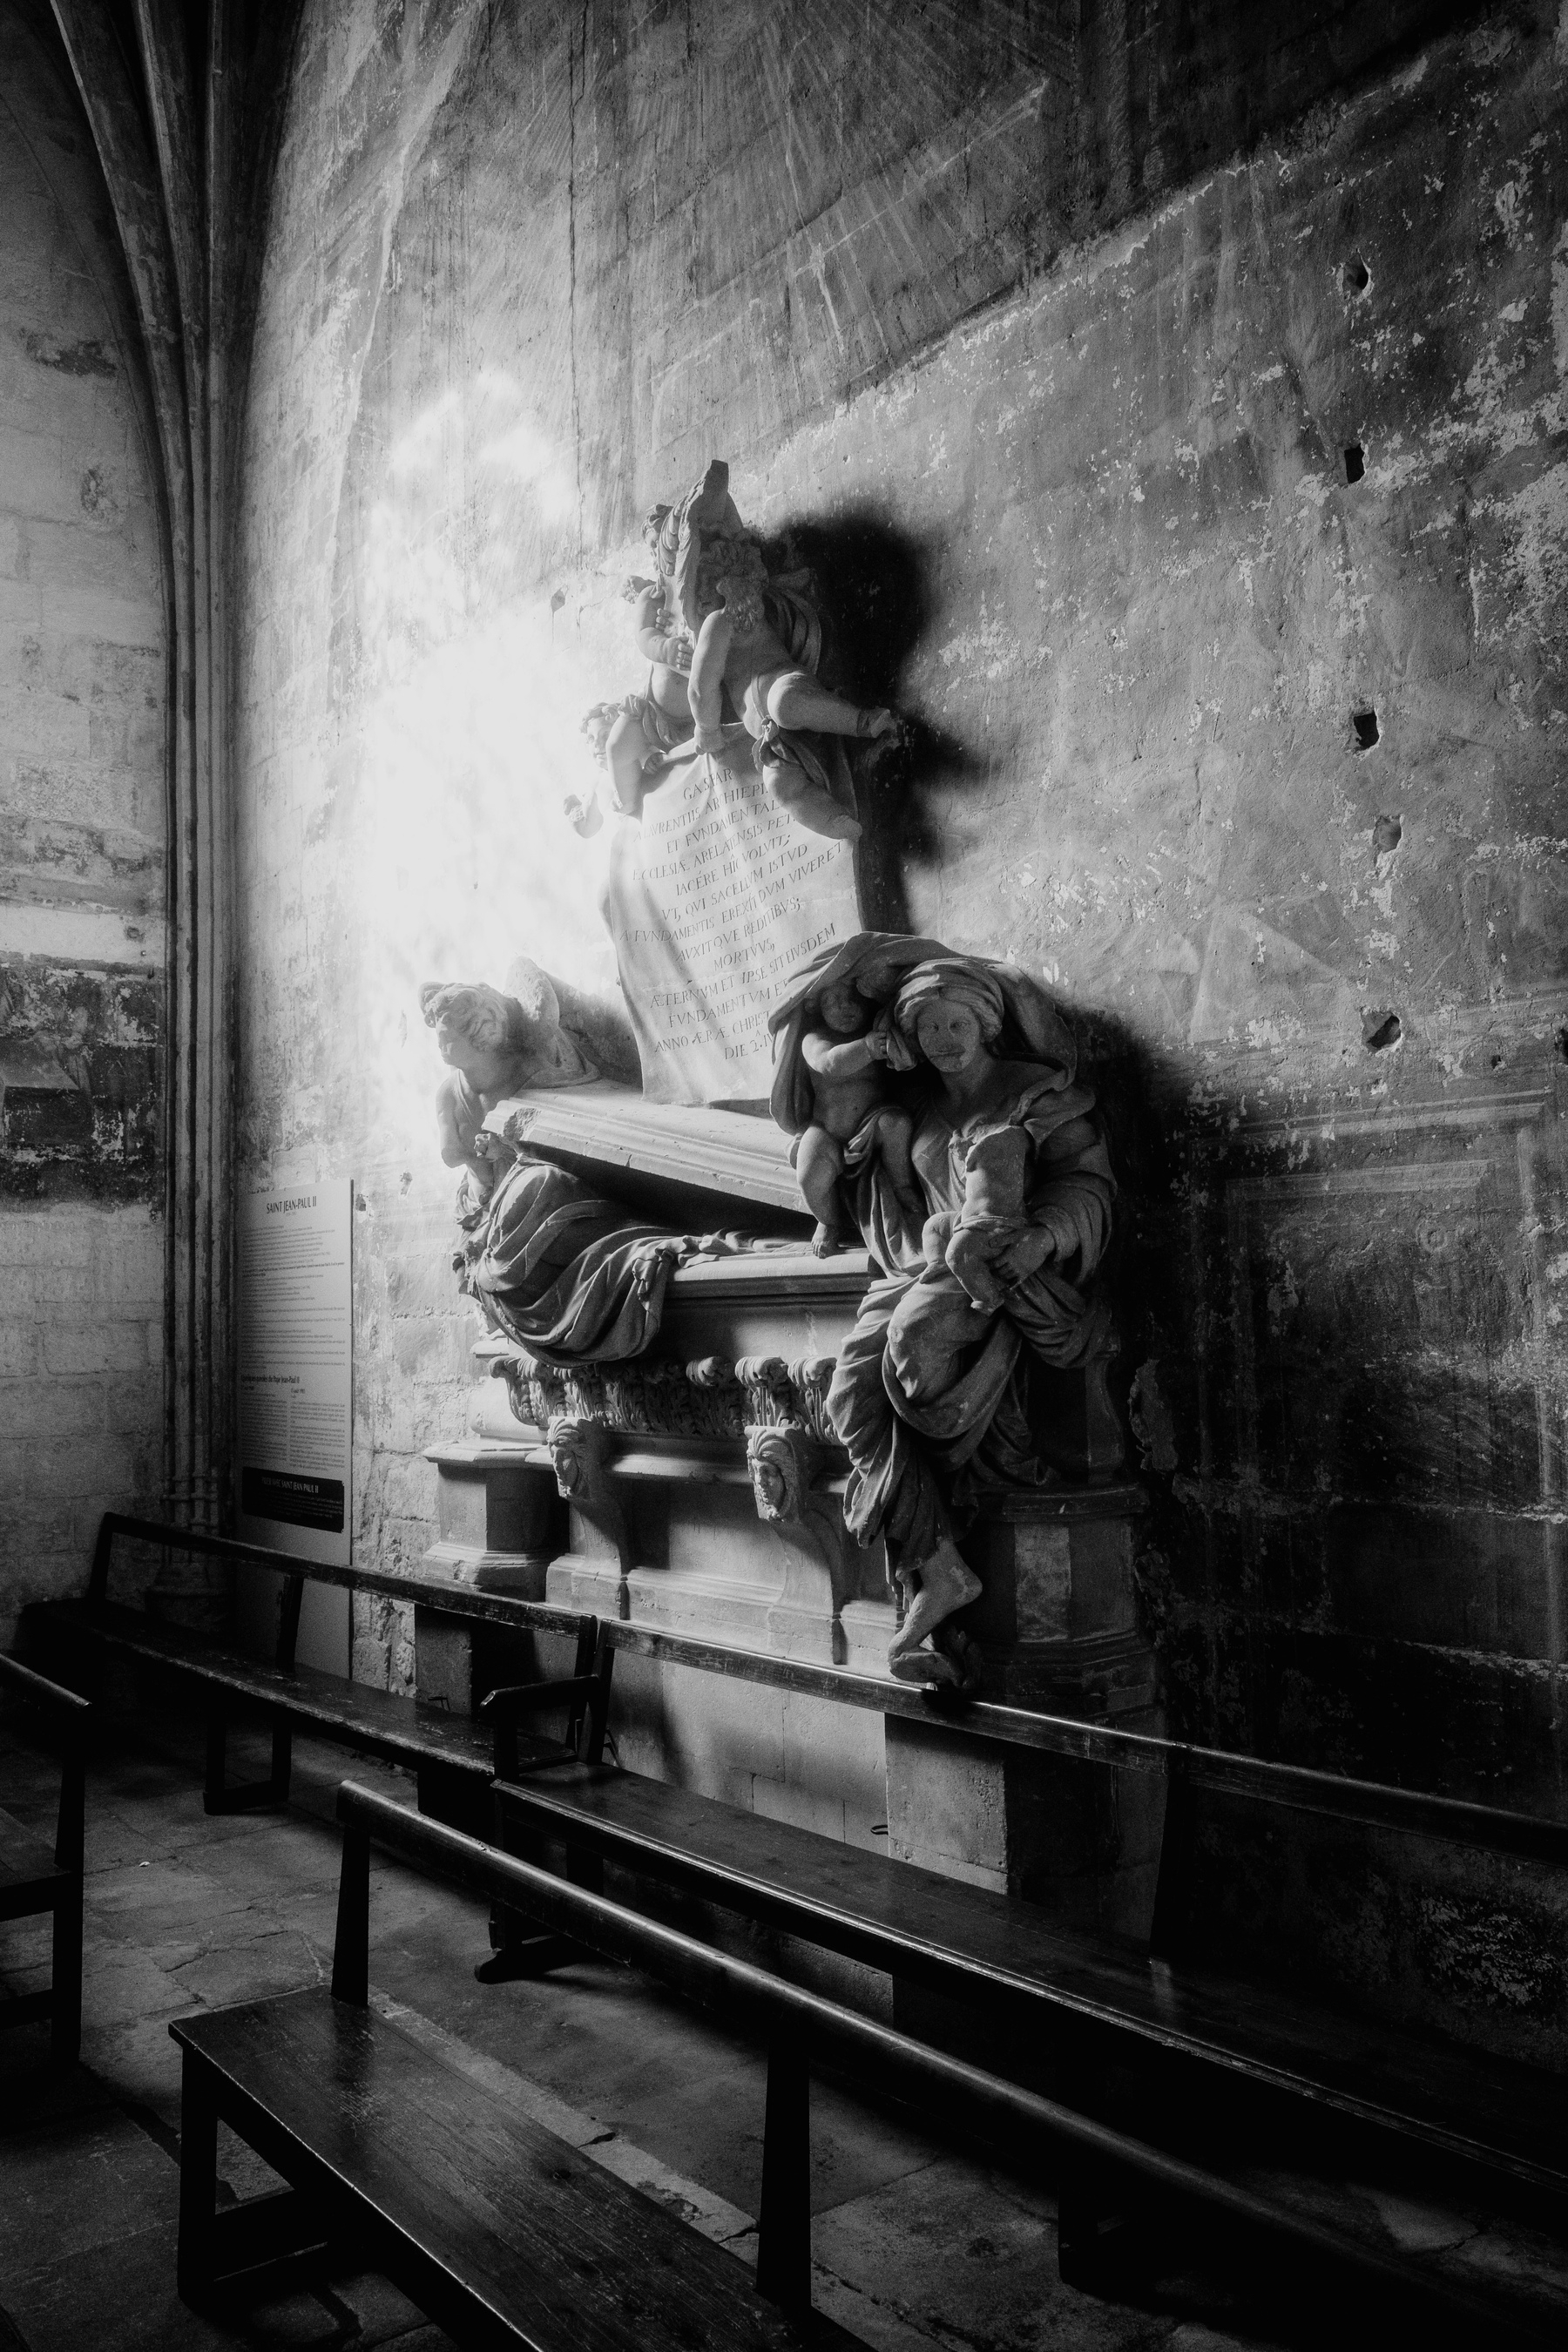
[0,1656,90,2065]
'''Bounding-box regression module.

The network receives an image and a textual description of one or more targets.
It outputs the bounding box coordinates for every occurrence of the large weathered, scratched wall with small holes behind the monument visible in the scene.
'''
[240,0,1568,1890]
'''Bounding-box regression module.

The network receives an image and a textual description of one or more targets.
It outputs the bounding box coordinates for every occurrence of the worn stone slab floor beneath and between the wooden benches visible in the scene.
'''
[0,1720,1568,2352]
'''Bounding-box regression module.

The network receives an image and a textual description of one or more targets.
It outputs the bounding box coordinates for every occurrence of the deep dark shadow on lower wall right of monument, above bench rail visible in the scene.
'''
[1079,1016,1561,1815]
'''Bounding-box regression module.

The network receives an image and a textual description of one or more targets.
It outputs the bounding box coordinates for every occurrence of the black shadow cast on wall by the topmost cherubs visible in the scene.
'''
[767,504,1010,931]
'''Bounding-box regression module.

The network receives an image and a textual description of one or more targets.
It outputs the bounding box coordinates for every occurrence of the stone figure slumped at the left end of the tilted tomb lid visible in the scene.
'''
[418,955,637,1204]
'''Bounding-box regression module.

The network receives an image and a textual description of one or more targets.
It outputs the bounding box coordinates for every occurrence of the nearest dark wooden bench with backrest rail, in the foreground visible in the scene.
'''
[169,1783,1544,2352]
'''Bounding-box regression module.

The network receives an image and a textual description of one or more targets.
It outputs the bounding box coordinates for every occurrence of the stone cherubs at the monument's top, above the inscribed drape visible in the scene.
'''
[573,459,898,840]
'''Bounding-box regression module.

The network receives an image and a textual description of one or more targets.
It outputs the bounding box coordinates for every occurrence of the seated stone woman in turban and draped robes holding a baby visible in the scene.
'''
[771,931,1117,1686]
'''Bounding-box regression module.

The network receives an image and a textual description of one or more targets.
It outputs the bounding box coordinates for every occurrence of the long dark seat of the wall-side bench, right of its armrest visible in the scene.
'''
[494,1727,1568,2204]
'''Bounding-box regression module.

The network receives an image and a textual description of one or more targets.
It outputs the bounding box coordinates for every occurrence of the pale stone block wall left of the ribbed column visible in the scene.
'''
[0,0,167,1639]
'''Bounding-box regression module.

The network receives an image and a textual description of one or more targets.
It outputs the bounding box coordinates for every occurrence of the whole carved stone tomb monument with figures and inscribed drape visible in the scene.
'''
[418,466,1154,1926]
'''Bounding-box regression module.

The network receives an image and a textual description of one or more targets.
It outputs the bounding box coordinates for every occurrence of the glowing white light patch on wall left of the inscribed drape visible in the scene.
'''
[339,369,620,1143]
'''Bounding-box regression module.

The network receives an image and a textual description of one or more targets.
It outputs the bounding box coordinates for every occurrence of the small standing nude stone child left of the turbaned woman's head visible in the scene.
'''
[792,981,922,1259]
